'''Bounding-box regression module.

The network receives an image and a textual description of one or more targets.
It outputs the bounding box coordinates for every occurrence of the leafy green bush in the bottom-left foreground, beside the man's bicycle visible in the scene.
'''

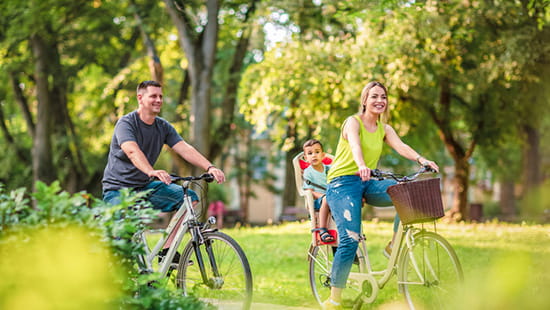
[0,182,210,309]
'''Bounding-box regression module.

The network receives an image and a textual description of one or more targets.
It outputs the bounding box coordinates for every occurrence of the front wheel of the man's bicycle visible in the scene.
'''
[176,231,252,309]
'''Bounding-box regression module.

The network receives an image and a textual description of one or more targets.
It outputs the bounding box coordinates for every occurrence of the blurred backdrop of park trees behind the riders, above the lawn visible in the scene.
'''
[0,0,550,308]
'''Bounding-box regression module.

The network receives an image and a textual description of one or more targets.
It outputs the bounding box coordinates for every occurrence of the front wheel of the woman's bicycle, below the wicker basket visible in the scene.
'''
[398,231,464,309]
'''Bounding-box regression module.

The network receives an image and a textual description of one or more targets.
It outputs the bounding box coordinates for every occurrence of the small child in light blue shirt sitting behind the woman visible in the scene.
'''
[303,139,335,243]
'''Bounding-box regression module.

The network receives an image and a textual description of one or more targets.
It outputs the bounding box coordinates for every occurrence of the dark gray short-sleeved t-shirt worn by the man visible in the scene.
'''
[102,111,183,192]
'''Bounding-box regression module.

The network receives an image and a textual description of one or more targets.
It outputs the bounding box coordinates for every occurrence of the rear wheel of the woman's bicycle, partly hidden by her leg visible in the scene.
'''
[308,244,366,307]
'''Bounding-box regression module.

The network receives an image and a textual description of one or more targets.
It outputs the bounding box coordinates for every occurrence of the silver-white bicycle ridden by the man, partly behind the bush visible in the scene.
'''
[135,174,252,309]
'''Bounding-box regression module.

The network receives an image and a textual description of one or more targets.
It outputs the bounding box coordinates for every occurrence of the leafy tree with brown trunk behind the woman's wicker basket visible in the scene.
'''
[372,1,547,218]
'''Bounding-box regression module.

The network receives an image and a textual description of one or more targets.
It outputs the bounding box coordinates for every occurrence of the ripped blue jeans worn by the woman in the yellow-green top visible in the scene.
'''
[326,175,399,288]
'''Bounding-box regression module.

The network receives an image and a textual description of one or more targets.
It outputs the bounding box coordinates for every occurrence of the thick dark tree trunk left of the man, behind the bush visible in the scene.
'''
[30,31,86,192]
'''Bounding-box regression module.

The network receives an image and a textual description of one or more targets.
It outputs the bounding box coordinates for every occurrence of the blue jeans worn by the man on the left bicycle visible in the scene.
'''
[103,181,199,212]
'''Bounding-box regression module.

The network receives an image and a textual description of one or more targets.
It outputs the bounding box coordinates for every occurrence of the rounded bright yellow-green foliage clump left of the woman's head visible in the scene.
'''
[240,41,358,152]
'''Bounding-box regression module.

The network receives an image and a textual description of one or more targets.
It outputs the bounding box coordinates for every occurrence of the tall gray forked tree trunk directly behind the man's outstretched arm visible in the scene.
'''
[164,0,259,170]
